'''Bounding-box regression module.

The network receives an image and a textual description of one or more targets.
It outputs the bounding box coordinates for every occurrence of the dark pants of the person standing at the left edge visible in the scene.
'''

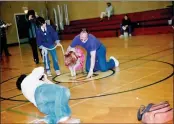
[0,35,9,56]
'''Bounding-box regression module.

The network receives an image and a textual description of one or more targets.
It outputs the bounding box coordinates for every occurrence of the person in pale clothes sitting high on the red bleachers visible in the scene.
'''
[100,3,114,21]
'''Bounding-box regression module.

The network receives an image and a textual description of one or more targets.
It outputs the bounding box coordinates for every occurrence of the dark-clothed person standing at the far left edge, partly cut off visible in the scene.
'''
[0,19,12,59]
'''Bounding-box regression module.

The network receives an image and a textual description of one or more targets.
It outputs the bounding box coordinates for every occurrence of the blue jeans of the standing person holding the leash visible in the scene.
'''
[44,46,59,70]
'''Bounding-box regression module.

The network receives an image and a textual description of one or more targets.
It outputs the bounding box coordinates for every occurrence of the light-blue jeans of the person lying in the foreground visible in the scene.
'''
[35,82,71,124]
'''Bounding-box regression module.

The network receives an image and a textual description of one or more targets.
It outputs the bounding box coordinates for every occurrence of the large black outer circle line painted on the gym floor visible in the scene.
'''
[0,59,174,102]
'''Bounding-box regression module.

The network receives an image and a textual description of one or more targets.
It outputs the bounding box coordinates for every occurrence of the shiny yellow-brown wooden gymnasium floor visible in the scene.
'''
[1,34,174,123]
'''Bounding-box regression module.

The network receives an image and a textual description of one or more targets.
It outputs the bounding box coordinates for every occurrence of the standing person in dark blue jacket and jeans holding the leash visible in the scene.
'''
[36,17,60,76]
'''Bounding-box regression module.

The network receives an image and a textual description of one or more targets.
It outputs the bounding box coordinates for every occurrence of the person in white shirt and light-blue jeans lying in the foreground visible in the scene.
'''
[16,67,80,124]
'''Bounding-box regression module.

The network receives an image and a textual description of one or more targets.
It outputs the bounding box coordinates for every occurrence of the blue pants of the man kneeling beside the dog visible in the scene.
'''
[86,45,115,72]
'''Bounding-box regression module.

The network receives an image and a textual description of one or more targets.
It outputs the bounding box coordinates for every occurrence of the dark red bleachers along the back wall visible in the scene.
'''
[59,7,173,40]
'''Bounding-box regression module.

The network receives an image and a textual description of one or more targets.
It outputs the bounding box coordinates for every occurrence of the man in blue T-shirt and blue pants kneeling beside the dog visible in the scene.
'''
[67,29,119,78]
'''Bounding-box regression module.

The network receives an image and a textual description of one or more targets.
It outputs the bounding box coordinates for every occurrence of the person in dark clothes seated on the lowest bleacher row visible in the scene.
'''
[120,15,132,38]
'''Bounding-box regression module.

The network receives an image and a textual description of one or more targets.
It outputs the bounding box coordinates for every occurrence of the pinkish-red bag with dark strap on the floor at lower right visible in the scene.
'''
[137,102,173,124]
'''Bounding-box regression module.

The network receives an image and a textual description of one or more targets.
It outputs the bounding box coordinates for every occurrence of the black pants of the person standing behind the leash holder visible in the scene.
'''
[29,38,41,63]
